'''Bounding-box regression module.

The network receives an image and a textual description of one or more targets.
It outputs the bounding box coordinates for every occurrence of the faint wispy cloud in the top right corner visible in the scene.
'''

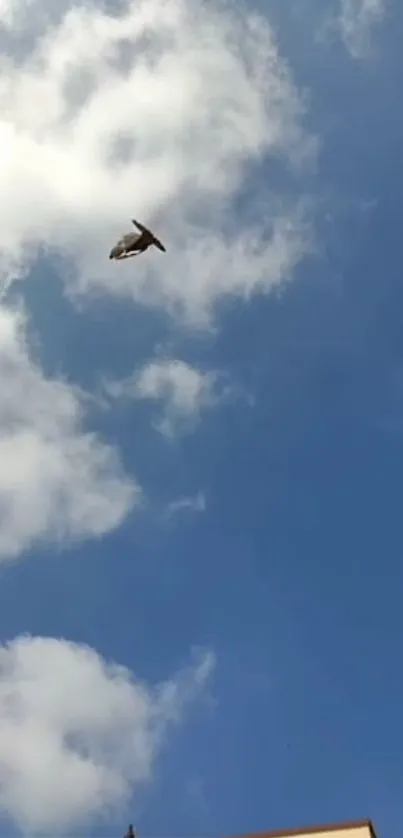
[338,0,386,58]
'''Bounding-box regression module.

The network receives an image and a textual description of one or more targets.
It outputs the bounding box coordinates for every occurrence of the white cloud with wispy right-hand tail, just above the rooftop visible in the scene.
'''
[0,637,215,835]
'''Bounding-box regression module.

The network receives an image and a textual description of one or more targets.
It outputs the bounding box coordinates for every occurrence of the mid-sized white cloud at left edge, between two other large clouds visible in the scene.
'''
[0,306,140,561]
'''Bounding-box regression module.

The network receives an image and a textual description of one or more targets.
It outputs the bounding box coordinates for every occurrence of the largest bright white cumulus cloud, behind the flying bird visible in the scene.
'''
[0,0,315,324]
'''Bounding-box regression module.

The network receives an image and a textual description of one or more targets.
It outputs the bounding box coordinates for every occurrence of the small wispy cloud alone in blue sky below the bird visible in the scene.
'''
[105,359,224,436]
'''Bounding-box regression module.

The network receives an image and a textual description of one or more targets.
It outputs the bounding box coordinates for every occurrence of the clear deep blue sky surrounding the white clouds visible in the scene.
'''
[0,0,403,838]
